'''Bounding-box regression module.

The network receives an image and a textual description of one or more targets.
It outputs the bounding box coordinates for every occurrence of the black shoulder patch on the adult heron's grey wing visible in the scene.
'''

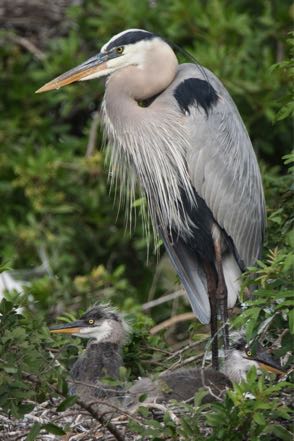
[174,78,218,116]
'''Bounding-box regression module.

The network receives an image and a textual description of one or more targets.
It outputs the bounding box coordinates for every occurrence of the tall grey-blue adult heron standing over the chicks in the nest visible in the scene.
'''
[37,29,265,368]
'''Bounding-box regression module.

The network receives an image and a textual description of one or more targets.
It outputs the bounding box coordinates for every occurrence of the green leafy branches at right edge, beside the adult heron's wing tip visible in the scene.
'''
[234,155,294,366]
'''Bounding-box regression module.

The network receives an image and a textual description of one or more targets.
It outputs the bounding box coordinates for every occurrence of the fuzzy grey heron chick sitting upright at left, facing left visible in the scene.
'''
[50,305,129,401]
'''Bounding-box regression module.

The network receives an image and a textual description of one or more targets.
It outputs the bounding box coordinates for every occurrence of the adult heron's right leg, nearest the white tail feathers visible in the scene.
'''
[214,239,229,351]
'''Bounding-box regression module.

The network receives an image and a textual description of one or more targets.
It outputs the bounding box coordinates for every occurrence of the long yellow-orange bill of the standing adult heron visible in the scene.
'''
[36,53,109,93]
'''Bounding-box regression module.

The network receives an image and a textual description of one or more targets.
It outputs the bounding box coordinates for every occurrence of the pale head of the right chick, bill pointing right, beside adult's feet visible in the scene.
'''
[224,339,285,382]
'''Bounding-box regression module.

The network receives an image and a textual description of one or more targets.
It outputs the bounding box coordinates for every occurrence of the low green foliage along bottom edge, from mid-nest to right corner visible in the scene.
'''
[129,368,292,441]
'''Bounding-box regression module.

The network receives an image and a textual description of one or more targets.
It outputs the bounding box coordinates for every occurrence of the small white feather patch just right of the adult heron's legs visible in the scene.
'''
[222,254,241,308]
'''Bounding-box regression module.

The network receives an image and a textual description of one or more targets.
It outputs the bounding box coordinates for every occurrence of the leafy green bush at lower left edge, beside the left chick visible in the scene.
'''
[0,296,63,417]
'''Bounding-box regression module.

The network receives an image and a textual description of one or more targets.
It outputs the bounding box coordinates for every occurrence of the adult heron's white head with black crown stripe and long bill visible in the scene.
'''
[36,29,177,93]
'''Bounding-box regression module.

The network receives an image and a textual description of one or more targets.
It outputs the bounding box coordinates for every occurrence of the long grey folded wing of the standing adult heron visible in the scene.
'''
[177,65,265,266]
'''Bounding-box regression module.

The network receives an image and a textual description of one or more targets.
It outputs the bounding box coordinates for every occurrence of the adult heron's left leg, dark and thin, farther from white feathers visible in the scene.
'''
[204,262,219,370]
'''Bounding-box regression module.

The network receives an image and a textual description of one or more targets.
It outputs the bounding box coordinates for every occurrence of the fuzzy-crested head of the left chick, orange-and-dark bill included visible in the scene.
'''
[50,305,128,344]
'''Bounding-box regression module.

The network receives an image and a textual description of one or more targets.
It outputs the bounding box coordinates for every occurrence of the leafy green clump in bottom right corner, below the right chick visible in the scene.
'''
[207,368,292,441]
